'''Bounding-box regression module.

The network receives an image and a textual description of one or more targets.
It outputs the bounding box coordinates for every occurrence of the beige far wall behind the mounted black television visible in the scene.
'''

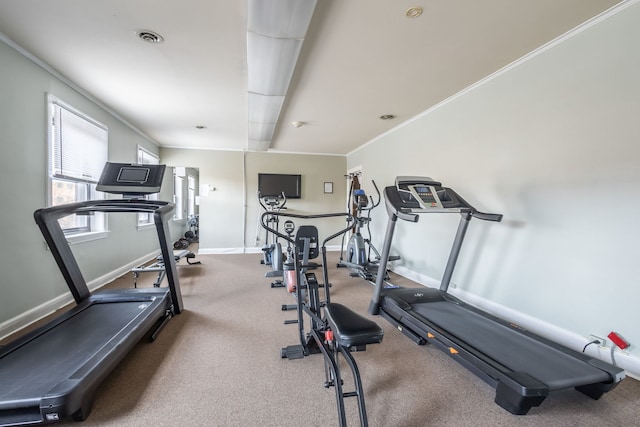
[160,148,346,253]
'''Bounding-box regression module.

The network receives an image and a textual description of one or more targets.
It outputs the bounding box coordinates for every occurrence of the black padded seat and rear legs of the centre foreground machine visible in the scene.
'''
[322,303,384,426]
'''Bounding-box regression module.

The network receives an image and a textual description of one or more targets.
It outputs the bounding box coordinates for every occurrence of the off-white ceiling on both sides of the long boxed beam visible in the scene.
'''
[0,0,620,155]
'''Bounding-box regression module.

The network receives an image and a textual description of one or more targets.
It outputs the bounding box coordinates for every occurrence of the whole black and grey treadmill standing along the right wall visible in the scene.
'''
[369,176,625,415]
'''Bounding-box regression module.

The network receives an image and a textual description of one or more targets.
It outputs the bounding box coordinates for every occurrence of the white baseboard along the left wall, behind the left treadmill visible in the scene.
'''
[0,250,160,339]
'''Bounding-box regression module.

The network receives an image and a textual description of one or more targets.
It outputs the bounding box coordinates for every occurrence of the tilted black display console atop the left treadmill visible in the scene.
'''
[96,162,165,194]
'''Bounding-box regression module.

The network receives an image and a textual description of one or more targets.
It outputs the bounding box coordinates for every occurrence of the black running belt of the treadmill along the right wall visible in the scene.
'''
[412,301,611,390]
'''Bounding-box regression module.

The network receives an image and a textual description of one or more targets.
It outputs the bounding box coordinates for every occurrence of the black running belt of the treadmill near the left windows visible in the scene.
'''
[0,298,161,401]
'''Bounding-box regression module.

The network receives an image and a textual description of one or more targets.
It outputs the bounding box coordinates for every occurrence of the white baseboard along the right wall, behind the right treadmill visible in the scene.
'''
[393,266,640,380]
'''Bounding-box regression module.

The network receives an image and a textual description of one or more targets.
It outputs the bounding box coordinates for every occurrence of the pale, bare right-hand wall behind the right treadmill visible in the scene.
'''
[347,2,640,375]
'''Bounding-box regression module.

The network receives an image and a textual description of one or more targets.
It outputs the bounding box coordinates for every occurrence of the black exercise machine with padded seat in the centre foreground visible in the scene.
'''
[261,212,384,427]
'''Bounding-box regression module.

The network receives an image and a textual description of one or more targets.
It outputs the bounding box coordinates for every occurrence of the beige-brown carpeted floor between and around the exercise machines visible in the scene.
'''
[10,252,640,427]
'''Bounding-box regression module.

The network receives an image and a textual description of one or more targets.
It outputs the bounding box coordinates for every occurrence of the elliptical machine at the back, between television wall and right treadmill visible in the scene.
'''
[337,180,400,283]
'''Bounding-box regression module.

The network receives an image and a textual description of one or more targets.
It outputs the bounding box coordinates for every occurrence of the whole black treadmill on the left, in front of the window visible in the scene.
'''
[0,163,183,426]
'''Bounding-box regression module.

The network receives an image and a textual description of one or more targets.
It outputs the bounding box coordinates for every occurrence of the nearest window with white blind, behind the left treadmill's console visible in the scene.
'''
[47,95,109,235]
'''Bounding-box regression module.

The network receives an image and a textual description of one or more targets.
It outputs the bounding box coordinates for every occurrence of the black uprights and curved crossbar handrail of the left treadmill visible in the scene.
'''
[33,199,183,314]
